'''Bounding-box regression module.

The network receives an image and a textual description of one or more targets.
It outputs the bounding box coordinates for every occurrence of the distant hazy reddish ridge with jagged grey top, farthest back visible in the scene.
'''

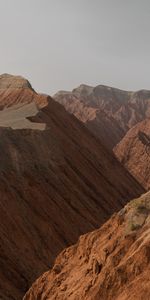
[54,85,150,149]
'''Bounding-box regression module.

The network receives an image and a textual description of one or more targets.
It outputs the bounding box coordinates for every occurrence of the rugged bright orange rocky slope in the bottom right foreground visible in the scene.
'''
[24,192,150,300]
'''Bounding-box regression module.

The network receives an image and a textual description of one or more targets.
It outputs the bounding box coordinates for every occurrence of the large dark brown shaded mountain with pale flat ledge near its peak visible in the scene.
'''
[0,75,143,300]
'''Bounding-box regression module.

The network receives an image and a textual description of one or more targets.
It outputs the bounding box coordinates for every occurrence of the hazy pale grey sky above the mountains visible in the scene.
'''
[0,0,150,94]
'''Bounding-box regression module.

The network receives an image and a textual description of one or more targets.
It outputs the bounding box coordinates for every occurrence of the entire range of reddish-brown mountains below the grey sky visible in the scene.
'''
[0,74,150,300]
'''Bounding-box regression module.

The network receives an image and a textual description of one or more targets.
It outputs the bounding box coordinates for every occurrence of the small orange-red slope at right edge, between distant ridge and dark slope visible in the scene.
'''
[114,119,150,190]
